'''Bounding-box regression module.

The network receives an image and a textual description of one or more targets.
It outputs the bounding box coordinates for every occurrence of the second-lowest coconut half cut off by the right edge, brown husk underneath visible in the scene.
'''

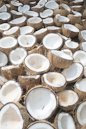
[74,78,86,99]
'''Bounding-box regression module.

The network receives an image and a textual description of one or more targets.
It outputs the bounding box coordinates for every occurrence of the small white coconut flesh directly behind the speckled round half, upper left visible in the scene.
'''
[20,26,34,35]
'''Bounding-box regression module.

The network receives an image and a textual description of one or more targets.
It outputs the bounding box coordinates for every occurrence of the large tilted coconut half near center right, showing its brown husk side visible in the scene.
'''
[48,50,73,68]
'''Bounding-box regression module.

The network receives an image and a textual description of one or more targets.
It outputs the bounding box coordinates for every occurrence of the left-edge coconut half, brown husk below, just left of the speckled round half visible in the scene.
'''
[0,36,17,54]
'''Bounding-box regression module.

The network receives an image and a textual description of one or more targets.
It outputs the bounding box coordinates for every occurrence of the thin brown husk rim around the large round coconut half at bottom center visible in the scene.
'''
[25,85,58,121]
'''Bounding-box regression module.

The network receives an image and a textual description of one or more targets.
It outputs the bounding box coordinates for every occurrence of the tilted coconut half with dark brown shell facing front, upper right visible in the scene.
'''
[62,24,79,38]
